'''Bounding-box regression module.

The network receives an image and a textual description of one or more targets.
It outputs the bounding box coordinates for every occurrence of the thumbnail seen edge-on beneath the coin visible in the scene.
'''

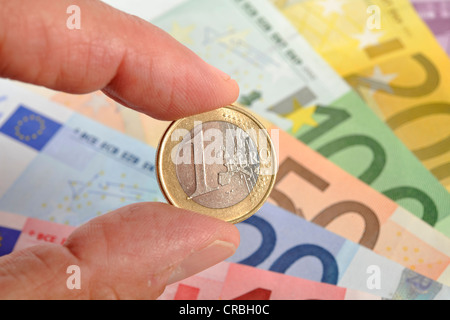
[167,240,236,284]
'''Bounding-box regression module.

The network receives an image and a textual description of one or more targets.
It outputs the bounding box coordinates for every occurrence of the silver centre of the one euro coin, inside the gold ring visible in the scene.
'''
[175,121,260,209]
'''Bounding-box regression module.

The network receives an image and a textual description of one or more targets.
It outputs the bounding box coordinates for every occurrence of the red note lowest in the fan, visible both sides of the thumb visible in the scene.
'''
[0,211,380,300]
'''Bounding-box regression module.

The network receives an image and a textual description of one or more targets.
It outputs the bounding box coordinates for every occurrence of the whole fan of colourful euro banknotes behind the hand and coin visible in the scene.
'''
[0,0,450,300]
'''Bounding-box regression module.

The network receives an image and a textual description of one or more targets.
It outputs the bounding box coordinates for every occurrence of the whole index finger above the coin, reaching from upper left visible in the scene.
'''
[0,0,239,120]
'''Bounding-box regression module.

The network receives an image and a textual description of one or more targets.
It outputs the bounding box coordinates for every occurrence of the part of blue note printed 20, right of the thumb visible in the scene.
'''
[228,203,450,300]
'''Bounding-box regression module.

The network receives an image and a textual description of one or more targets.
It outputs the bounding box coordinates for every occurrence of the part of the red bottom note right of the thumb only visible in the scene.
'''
[159,262,381,300]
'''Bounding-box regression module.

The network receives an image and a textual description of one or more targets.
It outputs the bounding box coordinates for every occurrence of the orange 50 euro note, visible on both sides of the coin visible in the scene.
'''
[26,88,450,285]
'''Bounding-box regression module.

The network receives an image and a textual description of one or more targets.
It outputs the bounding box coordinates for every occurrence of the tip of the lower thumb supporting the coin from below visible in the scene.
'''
[65,202,240,299]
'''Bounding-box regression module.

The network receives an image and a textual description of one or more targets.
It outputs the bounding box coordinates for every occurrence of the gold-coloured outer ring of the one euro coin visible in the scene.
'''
[156,105,278,223]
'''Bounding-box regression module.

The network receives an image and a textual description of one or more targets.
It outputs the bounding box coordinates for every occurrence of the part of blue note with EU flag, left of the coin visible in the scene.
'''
[0,79,164,226]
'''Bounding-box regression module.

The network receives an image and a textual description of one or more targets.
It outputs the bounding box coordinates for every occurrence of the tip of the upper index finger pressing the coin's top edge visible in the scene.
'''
[103,52,243,120]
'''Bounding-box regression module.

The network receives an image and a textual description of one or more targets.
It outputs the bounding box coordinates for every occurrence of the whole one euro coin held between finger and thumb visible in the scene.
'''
[156,105,277,223]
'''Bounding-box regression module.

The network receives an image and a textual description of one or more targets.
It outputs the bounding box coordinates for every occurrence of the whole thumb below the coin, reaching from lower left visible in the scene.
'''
[0,203,239,299]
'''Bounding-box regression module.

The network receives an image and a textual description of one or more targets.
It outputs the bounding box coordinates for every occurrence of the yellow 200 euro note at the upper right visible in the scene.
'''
[273,0,450,190]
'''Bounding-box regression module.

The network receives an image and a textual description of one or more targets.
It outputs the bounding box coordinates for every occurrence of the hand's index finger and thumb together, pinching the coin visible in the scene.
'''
[0,0,239,299]
